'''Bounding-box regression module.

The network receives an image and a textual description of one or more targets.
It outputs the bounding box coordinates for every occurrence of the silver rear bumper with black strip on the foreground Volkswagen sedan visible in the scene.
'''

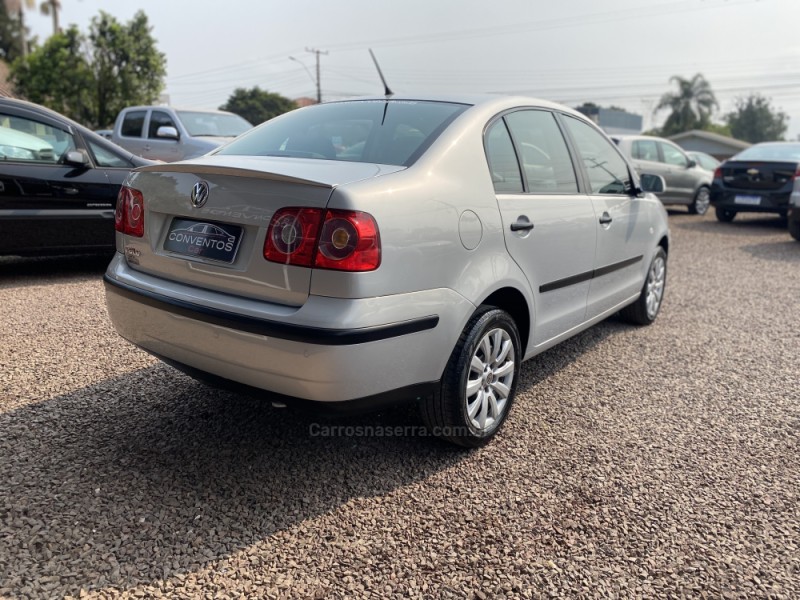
[105,255,474,402]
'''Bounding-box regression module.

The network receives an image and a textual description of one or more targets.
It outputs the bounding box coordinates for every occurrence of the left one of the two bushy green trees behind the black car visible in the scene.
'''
[11,25,94,123]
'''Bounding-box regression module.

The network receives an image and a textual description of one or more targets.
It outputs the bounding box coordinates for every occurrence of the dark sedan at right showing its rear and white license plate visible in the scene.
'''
[711,142,800,222]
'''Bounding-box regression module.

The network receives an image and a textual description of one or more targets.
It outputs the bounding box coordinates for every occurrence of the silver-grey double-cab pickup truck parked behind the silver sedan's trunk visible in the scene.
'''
[111,106,252,162]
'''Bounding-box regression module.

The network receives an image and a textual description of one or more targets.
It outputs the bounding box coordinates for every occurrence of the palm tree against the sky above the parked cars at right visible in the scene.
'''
[655,73,719,135]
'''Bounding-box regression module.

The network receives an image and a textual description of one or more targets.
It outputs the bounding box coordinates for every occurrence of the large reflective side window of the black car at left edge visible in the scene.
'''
[0,114,75,163]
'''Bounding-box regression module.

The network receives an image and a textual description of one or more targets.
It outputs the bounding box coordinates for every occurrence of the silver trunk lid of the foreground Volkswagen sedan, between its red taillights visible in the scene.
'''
[123,156,403,306]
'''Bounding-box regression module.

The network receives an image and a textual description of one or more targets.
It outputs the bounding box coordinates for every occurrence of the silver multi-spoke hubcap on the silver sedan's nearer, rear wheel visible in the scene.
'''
[466,328,514,431]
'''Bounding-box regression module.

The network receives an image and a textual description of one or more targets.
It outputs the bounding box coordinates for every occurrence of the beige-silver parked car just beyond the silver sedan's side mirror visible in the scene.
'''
[611,135,712,215]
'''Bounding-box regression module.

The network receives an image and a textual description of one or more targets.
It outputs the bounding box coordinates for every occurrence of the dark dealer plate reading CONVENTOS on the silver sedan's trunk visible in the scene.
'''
[164,219,242,263]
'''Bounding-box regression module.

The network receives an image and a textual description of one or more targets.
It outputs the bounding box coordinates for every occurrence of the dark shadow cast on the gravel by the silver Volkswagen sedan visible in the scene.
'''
[0,320,629,597]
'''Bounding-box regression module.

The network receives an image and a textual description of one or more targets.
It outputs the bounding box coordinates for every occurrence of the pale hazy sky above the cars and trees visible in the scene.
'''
[28,0,800,139]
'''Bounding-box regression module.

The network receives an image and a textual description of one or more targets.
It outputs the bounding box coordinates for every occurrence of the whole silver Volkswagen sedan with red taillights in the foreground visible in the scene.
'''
[105,96,669,446]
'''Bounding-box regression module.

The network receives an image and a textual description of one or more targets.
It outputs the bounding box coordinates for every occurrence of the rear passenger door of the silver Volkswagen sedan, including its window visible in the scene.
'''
[485,109,597,346]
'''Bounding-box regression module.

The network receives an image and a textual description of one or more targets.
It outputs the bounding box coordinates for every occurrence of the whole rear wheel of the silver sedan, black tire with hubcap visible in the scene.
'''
[420,306,522,448]
